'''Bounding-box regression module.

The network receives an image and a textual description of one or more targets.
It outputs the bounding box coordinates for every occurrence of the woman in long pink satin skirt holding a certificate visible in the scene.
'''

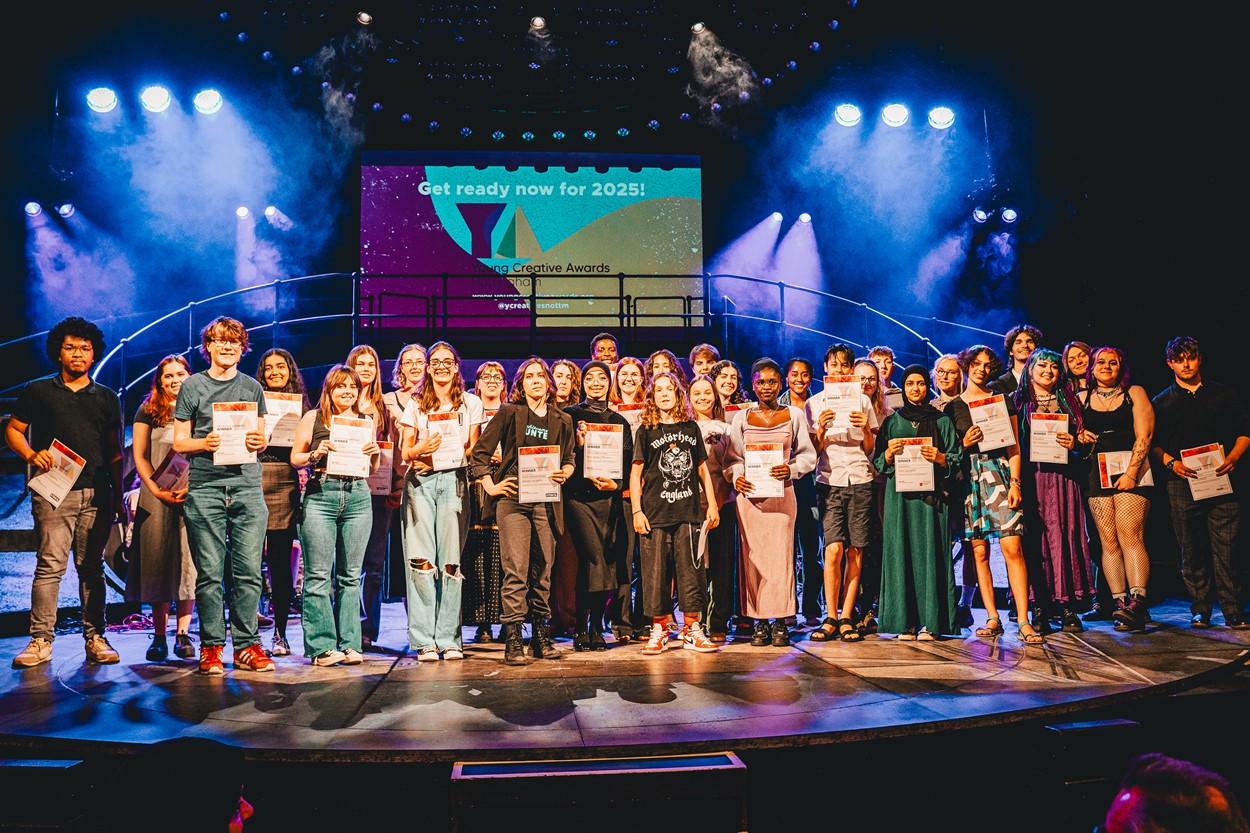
[725,358,816,648]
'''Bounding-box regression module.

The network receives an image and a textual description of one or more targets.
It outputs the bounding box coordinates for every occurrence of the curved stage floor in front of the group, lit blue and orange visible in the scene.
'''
[0,592,1250,763]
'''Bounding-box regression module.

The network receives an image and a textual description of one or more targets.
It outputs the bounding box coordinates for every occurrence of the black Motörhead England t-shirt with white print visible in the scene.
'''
[634,419,708,527]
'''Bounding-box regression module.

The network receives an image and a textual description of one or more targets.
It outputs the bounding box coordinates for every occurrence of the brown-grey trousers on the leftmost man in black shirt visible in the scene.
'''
[30,489,113,642]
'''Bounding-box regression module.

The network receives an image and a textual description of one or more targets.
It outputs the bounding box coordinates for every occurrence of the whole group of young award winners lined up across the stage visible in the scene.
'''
[6,316,1250,674]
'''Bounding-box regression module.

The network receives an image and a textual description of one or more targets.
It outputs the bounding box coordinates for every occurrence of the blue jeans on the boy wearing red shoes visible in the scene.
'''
[183,482,269,650]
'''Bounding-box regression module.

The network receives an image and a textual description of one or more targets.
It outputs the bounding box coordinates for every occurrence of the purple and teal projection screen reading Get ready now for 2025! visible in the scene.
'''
[360,151,704,326]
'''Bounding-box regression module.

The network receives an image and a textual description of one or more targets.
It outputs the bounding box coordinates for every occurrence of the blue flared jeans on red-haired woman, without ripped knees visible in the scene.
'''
[300,474,374,658]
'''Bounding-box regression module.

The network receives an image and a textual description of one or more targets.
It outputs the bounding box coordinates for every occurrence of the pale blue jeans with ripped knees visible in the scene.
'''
[403,469,469,650]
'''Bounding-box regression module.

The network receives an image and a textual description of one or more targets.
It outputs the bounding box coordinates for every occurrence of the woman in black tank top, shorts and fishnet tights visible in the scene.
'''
[1076,346,1155,630]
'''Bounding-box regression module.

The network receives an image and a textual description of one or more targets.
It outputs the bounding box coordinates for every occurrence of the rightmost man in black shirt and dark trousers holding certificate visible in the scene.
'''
[1153,335,1250,629]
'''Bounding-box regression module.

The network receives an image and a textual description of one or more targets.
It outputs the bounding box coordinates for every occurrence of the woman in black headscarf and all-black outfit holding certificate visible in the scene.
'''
[564,360,634,650]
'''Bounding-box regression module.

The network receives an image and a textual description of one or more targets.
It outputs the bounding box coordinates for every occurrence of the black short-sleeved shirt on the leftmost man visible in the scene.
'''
[13,373,121,489]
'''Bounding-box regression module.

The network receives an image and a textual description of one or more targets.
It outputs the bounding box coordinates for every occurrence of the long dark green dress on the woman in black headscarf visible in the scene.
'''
[874,414,963,634]
